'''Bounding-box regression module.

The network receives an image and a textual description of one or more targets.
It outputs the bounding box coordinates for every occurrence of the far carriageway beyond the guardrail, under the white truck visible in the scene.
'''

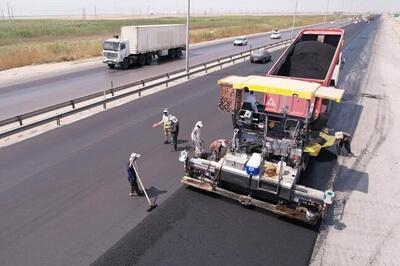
[0,22,342,120]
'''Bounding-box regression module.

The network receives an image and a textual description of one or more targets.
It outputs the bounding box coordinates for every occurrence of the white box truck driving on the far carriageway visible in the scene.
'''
[103,24,186,69]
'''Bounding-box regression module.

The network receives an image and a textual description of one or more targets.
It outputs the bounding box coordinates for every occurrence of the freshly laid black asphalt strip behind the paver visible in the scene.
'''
[93,188,316,266]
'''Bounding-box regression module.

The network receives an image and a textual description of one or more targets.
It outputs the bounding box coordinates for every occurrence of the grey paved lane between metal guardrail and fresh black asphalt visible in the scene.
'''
[0,21,374,265]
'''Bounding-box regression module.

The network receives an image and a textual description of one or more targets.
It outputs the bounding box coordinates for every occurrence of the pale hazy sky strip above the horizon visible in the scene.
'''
[0,0,400,19]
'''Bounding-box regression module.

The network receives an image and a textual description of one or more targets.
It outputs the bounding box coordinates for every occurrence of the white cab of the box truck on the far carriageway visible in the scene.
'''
[103,38,129,69]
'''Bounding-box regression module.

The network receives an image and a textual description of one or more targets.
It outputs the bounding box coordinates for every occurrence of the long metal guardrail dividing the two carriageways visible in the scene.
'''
[0,39,292,139]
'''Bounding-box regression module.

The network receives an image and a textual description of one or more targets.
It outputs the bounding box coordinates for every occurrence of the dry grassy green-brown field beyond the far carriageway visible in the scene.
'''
[0,16,335,71]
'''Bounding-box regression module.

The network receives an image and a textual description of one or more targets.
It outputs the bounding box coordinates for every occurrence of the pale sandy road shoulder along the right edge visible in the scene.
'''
[311,17,400,265]
